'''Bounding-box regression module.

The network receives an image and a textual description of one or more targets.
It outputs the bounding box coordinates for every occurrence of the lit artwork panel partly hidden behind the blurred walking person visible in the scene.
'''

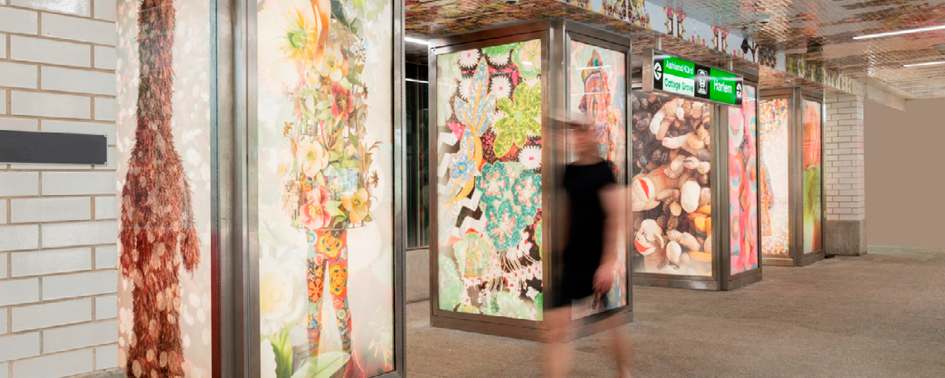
[568,41,627,317]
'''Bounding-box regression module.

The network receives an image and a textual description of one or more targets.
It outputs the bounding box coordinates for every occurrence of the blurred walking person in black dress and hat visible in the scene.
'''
[545,115,630,378]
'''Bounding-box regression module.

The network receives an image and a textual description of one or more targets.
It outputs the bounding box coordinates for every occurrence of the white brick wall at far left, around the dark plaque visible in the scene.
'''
[0,0,118,378]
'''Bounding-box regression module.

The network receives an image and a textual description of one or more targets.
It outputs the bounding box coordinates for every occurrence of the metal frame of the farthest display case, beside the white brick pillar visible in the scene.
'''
[758,87,827,267]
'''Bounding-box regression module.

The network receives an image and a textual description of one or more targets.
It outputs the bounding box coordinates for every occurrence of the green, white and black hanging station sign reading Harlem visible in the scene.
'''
[644,50,743,106]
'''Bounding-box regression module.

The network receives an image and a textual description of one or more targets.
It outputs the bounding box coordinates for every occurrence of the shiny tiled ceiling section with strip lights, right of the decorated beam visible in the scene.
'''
[655,0,945,98]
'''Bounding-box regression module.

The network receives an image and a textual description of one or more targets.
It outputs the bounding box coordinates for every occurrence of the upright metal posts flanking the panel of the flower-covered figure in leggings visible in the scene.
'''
[232,0,407,378]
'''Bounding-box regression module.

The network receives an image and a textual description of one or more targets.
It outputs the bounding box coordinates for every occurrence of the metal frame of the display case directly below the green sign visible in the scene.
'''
[630,70,766,290]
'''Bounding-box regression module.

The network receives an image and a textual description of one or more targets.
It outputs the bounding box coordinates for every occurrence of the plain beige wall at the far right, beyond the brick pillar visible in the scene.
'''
[864,99,945,248]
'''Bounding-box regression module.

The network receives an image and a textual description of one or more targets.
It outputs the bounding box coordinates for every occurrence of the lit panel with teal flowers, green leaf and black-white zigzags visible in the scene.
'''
[436,40,543,320]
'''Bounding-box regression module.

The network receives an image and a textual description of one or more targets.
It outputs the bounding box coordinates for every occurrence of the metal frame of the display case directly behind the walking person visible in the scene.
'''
[427,19,633,340]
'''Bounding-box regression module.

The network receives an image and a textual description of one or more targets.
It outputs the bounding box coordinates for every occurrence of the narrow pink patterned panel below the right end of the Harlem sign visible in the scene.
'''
[728,85,758,275]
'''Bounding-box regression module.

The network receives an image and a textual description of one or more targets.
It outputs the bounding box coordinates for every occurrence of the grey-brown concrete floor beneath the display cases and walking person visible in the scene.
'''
[407,246,945,378]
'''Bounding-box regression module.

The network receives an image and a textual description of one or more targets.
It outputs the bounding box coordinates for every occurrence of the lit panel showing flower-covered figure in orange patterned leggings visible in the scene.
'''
[257,0,394,378]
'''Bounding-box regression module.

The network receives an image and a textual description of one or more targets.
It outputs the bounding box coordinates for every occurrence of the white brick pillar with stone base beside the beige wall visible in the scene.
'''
[824,93,866,255]
